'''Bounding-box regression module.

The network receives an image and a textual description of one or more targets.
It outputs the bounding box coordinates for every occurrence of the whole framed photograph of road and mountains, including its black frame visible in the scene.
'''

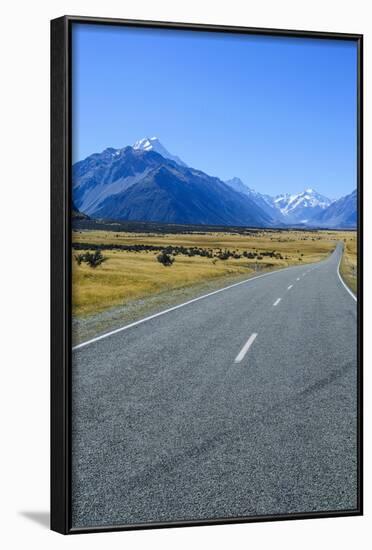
[51,16,363,534]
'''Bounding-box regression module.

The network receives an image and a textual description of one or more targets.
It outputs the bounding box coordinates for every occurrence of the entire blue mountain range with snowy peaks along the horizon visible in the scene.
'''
[72,137,357,233]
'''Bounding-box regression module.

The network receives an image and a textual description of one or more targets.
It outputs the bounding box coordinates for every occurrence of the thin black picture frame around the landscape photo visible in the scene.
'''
[51,16,363,534]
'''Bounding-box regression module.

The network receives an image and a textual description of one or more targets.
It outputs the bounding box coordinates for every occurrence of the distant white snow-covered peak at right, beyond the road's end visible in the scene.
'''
[274,188,333,224]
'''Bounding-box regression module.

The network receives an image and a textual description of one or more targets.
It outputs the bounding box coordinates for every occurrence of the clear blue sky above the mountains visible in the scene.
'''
[72,24,357,198]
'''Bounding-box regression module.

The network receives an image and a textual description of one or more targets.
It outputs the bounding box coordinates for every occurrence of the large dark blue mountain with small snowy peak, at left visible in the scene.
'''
[72,143,272,227]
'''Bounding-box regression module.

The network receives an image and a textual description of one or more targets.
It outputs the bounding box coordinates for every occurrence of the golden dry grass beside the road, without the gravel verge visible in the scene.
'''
[72,230,355,318]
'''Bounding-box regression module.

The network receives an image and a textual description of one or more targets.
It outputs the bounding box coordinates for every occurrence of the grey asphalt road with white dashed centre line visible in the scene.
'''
[72,245,357,527]
